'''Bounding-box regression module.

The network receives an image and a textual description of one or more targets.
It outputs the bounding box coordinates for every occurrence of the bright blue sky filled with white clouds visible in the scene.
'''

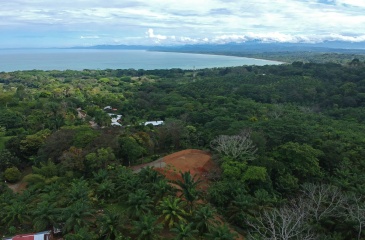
[0,0,365,48]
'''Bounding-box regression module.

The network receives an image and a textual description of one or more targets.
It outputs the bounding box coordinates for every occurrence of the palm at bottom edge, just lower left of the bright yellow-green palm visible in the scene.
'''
[132,214,162,240]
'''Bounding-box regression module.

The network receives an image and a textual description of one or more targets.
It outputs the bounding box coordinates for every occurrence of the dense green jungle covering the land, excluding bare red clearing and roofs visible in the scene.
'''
[0,59,365,240]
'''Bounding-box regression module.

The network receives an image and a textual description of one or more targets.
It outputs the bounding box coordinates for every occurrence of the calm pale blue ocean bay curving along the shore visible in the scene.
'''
[0,49,281,72]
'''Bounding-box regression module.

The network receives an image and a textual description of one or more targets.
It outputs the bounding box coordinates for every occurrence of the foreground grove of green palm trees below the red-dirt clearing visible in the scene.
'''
[0,166,235,239]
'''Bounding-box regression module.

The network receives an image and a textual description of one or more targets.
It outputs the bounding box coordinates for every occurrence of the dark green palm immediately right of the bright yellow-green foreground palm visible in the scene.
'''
[192,205,219,235]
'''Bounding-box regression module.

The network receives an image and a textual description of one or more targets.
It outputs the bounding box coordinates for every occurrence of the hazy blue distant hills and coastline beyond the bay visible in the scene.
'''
[70,41,365,64]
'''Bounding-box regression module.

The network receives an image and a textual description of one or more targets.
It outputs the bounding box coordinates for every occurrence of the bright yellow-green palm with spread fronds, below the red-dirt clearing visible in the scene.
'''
[159,196,188,228]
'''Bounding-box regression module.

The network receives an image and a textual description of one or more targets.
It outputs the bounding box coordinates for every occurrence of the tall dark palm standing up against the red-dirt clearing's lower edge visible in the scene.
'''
[174,171,202,210]
